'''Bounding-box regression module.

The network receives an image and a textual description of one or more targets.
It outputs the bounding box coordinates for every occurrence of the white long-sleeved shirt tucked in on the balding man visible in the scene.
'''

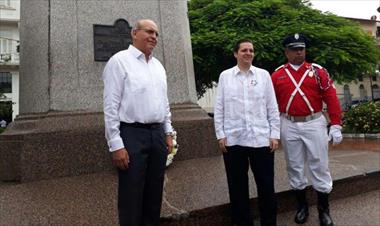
[103,45,173,152]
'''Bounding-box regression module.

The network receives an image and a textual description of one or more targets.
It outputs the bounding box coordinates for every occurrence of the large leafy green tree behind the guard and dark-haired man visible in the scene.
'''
[189,0,380,97]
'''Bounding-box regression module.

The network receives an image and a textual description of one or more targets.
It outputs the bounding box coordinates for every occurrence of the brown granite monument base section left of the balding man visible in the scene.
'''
[0,112,112,182]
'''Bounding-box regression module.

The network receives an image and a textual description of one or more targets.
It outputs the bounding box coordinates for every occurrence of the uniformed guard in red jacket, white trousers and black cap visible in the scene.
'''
[272,34,342,226]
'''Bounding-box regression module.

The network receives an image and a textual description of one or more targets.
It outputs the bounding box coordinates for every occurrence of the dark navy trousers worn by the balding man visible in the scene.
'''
[118,123,168,226]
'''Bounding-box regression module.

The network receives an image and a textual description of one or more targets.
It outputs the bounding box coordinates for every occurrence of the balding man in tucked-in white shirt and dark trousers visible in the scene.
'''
[103,19,173,226]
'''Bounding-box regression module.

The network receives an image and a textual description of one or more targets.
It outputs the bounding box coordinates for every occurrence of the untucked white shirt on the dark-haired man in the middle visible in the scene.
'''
[214,66,280,147]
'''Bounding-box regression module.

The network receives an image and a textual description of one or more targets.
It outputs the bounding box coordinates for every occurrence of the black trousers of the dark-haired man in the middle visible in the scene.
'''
[223,146,277,226]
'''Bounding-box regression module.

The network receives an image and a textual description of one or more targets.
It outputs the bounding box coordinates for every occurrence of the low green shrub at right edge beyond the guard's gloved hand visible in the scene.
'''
[343,102,380,133]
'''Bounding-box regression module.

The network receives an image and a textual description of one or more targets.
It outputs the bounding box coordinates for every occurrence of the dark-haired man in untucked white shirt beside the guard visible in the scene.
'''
[214,40,280,226]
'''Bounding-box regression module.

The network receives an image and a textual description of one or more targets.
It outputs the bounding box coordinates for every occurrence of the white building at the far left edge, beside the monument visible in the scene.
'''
[0,0,20,122]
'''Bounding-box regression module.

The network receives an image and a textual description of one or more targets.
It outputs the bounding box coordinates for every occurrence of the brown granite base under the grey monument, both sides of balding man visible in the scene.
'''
[0,104,219,182]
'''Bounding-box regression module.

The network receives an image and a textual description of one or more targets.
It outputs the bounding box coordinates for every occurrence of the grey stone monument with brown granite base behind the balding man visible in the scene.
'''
[0,0,218,182]
